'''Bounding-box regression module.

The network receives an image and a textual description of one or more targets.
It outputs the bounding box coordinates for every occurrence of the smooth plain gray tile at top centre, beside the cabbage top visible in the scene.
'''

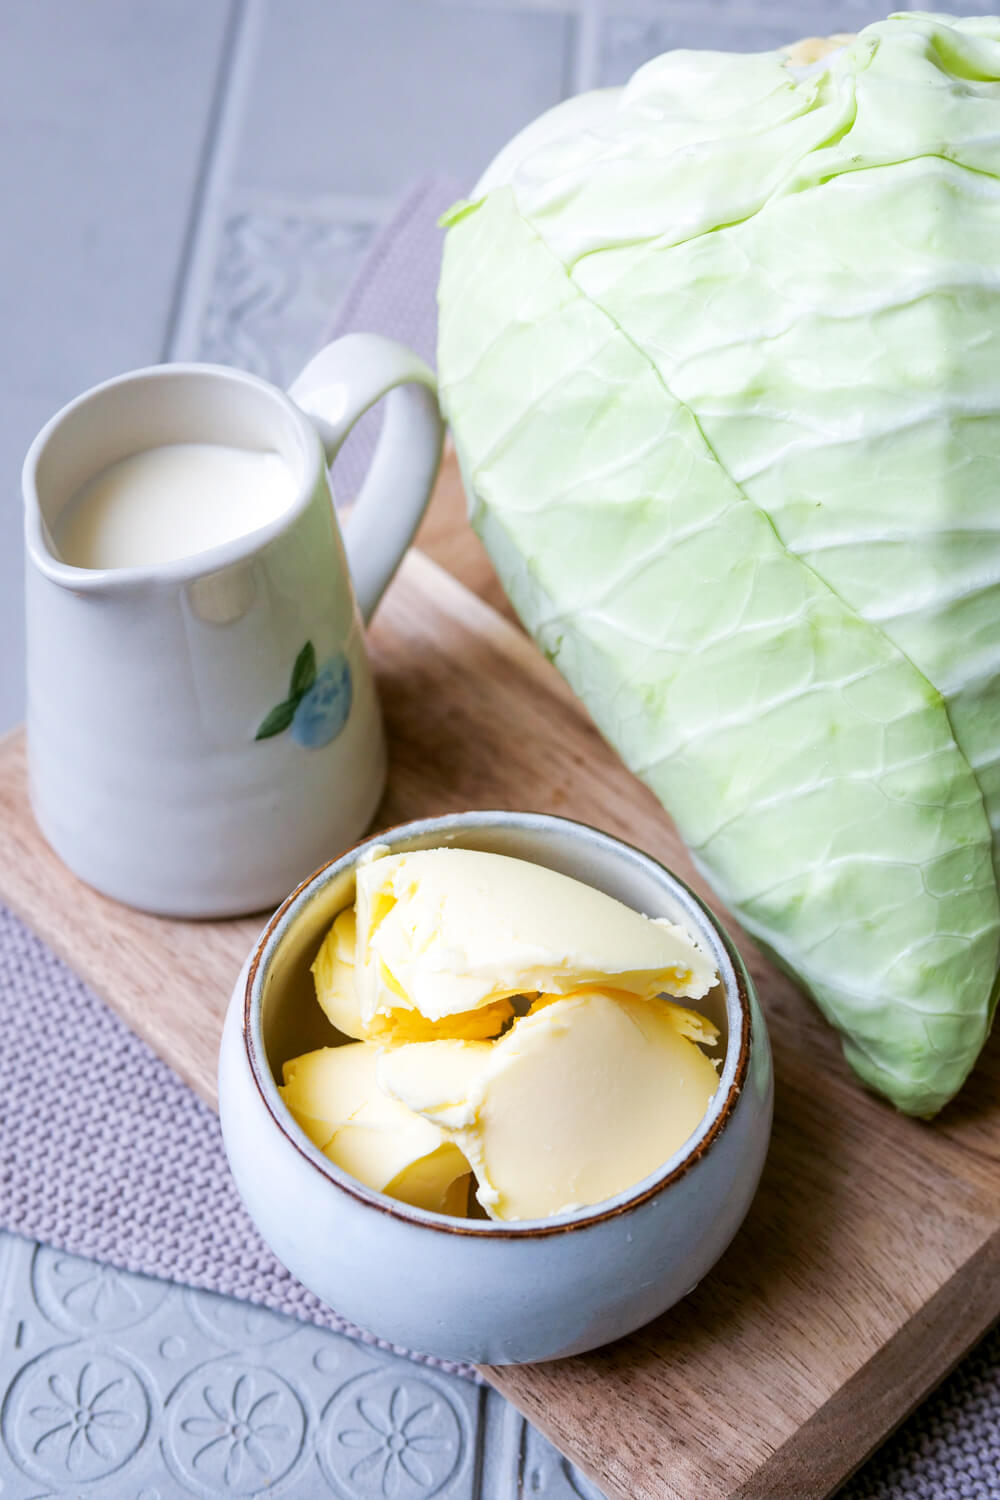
[234,0,571,195]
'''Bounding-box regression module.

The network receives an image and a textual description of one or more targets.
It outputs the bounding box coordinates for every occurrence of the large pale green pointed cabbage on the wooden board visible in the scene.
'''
[439,14,1000,1115]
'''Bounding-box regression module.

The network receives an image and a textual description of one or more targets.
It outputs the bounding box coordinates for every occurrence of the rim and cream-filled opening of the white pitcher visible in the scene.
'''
[22,365,325,594]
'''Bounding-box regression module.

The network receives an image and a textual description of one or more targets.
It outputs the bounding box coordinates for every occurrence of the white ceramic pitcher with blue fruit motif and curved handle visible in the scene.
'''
[24,335,442,917]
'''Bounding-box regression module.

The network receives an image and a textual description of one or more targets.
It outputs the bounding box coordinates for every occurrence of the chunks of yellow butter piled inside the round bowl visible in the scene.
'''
[280,848,718,1223]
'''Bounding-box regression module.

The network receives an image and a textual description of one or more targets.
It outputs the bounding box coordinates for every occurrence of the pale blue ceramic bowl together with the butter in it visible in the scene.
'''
[220,813,771,1364]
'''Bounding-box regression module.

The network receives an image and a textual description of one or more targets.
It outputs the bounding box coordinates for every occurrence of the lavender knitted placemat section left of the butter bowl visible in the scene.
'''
[0,906,472,1374]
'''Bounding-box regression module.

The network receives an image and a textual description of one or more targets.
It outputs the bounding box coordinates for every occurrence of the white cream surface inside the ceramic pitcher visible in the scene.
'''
[52,443,297,569]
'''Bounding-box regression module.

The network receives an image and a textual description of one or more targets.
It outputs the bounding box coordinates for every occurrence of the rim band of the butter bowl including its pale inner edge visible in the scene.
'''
[240,809,754,1241]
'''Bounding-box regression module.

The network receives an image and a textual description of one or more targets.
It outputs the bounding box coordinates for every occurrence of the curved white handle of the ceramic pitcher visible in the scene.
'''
[288,333,444,624]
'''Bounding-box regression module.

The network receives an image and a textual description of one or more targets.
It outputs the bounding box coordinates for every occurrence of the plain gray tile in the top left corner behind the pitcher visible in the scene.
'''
[0,0,231,729]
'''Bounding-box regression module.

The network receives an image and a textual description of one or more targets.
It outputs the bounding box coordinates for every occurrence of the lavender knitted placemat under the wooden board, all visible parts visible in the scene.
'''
[0,179,1000,1500]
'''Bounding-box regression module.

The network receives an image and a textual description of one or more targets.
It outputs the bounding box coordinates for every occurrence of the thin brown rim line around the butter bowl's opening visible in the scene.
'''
[241,809,753,1239]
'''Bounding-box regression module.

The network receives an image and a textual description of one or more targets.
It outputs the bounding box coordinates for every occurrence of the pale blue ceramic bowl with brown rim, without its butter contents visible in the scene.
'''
[219,812,772,1365]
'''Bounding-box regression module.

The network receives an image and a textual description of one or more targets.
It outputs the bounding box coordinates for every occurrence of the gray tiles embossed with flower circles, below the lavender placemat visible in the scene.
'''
[0,1236,597,1500]
